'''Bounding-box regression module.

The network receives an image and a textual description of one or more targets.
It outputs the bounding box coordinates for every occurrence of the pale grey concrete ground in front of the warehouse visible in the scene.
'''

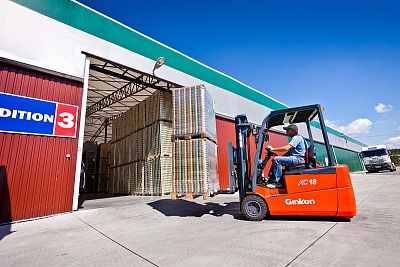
[0,171,400,266]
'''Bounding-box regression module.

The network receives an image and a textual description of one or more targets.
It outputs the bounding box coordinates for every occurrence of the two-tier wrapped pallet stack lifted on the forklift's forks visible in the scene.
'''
[171,85,219,198]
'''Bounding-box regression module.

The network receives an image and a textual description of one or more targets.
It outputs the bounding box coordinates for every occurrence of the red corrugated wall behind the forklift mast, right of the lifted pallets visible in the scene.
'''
[216,114,288,191]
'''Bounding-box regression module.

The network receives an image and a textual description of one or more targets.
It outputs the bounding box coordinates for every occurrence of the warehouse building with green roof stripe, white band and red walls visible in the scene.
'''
[0,0,364,223]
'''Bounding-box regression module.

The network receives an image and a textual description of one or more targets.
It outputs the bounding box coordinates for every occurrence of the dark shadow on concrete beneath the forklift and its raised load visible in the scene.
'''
[148,199,349,222]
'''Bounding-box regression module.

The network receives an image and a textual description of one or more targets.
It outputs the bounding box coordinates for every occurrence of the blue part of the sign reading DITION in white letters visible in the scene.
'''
[0,93,57,135]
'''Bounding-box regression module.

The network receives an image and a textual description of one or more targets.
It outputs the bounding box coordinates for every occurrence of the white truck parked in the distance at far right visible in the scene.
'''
[361,145,396,172]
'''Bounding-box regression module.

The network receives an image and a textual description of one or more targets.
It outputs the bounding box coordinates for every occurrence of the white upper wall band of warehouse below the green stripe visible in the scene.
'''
[0,0,361,151]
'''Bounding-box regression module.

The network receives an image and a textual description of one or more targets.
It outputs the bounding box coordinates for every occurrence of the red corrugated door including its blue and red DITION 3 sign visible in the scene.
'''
[0,63,83,223]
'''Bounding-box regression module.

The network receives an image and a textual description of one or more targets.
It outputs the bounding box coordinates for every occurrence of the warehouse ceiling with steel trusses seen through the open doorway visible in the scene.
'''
[84,53,182,143]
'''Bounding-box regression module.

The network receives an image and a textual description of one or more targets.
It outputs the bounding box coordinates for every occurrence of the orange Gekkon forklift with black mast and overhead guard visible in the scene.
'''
[235,105,356,221]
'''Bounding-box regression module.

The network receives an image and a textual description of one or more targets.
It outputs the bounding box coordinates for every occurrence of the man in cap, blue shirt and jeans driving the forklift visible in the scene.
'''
[267,124,307,188]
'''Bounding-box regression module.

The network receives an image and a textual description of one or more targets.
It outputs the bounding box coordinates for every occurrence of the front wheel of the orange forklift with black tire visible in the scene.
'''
[241,195,268,221]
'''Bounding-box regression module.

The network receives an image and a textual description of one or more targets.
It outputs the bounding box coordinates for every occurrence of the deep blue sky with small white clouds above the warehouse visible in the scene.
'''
[80,0,400,147]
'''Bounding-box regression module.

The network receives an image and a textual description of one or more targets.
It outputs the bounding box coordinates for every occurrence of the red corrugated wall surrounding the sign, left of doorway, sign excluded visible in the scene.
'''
[0,63,83,222]
